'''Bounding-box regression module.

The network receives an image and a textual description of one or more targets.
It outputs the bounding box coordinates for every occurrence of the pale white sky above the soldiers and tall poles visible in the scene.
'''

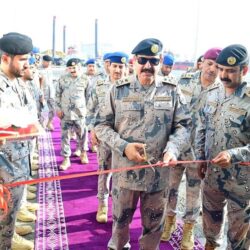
[0,0,250,60]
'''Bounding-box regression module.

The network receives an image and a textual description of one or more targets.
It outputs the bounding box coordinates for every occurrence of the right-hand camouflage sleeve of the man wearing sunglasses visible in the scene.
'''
[163,87,191,158]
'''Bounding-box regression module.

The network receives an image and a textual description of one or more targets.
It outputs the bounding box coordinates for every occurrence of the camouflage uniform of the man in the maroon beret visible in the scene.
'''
[167,71,219,223]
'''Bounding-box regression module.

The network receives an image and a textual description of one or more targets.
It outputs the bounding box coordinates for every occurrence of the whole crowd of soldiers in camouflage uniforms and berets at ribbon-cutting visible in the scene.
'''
[0,32,250,250]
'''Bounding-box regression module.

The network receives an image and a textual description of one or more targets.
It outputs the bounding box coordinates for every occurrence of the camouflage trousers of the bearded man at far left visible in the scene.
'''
[0,169,27,250]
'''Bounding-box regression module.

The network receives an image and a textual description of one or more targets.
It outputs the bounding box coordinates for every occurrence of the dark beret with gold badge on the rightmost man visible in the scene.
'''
[216,44,249,67]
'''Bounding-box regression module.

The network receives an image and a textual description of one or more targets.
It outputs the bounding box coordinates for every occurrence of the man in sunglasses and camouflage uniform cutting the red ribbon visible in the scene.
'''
[95,38,190,250]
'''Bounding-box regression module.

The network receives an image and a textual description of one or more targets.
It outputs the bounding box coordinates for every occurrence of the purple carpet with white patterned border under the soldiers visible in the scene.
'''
[36,119,204,250]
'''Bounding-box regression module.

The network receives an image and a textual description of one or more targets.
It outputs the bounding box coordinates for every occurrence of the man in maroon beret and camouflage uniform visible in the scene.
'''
[162,48,221,250]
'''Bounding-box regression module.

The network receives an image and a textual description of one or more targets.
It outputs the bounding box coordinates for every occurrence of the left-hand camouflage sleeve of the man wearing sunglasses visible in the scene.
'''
[95,86,128,156]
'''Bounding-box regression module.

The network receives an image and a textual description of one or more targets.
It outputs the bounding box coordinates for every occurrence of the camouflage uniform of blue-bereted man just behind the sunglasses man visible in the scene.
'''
[87,77,112,206]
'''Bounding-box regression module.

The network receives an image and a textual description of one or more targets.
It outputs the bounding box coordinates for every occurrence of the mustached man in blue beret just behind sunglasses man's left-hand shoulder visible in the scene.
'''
[88,52,128,223]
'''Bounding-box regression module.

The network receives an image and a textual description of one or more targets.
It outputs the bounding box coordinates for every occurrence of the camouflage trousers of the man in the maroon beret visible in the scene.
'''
[167,164,201,223]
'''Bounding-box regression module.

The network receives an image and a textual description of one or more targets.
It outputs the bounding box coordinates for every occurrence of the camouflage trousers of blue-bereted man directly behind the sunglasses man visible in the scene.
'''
[97,143,112,206]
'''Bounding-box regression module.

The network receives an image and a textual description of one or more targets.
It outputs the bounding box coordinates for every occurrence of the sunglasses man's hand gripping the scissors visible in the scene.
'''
[124,143,146,163]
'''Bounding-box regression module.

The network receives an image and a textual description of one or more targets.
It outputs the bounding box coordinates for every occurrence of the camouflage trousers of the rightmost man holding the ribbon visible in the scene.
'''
[202,181,250,250]
